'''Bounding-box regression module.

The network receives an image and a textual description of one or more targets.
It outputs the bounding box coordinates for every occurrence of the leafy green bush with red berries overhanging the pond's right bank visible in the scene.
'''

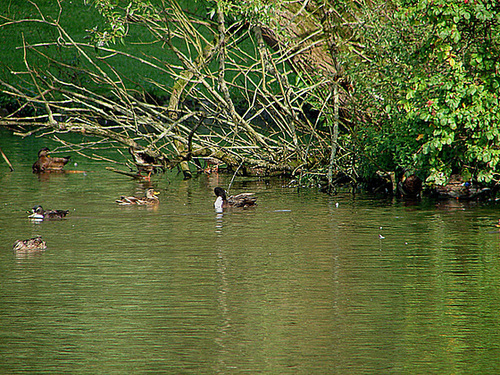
[346,0,500,183]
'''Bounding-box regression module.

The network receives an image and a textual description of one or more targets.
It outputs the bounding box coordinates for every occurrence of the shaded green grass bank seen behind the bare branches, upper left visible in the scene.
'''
[0,0,282,105]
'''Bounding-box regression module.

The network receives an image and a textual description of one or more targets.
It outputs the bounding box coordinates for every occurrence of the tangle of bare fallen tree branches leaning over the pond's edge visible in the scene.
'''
[0,0,349,180]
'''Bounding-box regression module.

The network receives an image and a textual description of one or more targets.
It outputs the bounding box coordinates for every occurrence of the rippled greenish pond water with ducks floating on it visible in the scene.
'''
[0,129,500,374]
